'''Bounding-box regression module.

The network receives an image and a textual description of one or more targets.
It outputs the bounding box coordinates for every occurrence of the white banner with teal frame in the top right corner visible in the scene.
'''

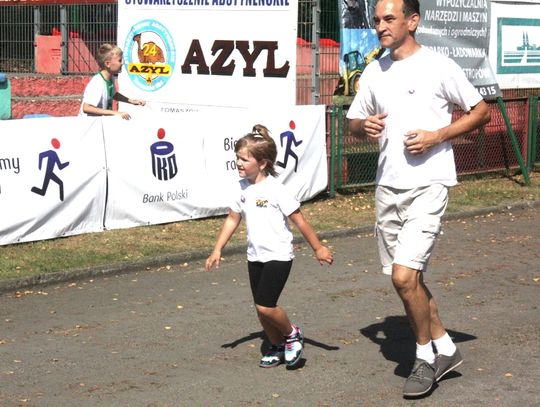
[489,1,540,89]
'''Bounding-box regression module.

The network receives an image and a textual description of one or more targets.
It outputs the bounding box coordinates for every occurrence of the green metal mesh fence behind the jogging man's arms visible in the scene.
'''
[328,95,540,195]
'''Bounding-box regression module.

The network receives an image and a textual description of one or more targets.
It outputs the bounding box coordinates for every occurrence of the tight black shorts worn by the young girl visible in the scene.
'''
[248,260,292,308]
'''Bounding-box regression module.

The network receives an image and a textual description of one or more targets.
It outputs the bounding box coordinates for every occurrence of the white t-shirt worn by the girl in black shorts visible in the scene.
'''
[231,176,300,262]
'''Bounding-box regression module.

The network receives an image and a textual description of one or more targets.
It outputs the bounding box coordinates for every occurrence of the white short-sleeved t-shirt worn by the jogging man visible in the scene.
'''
[347,46,482,189]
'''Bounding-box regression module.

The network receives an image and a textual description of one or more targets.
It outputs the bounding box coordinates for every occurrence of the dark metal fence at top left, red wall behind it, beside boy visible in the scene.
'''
[0,0,118,74]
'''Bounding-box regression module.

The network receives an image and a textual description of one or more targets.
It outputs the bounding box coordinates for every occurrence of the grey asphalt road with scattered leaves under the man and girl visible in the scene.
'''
[0,206,540,407]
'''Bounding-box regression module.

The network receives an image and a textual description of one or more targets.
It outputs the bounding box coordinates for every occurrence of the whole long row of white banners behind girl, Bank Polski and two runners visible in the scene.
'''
[0,105,328,245]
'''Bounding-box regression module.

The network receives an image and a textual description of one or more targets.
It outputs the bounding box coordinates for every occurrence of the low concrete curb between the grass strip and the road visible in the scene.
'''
[0,201,540,293]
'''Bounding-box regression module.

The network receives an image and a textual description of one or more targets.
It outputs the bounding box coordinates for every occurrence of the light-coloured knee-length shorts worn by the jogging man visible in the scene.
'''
[375,184,448,275]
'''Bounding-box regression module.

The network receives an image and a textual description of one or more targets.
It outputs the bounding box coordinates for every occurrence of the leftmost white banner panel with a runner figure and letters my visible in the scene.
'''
[0,117,106,244]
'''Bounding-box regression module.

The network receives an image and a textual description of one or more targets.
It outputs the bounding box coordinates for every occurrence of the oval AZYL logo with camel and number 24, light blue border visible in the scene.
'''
[124,20,176,92]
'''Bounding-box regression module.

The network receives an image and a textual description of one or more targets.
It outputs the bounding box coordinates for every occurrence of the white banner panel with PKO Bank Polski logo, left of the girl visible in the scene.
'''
[103,114,215,229]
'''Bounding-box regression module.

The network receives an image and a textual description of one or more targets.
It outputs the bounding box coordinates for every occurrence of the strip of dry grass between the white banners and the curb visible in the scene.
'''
[0,173,540,279]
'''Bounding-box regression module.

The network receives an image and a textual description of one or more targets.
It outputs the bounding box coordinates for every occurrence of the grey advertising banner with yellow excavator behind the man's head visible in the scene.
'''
[334,0,502,99]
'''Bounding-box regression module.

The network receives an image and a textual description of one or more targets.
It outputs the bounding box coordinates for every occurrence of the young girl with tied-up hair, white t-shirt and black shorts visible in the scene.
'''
[206,125,333,367]
